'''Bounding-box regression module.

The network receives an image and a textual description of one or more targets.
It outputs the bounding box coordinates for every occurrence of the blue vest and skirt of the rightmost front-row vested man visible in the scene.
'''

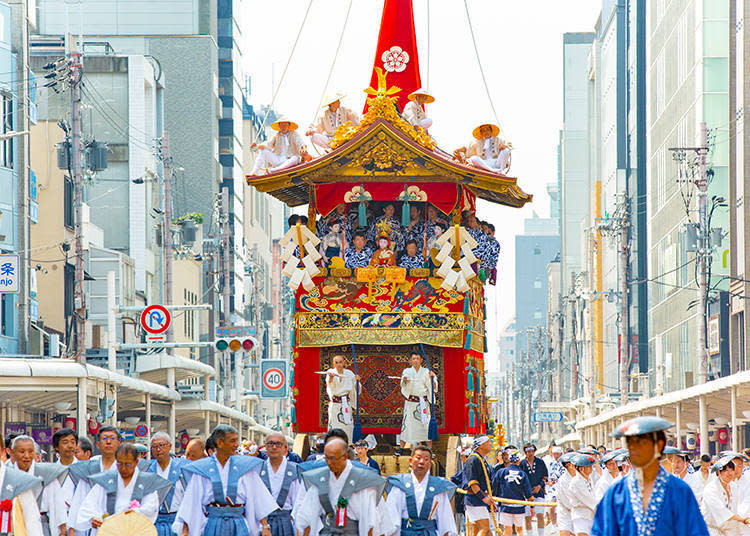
[386,473,456,536]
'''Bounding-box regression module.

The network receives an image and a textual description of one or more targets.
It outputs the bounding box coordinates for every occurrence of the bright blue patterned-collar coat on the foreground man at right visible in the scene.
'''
[591,468,708,536]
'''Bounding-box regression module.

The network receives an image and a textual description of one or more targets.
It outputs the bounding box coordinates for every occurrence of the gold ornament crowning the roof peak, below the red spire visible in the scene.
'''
[331,67,435,150]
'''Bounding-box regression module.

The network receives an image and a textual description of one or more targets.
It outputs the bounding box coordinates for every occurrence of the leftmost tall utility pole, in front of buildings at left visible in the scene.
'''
[68,43,86,363]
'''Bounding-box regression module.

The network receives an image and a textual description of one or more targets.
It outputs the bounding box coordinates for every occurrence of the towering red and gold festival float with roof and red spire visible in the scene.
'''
[246,0,532,468]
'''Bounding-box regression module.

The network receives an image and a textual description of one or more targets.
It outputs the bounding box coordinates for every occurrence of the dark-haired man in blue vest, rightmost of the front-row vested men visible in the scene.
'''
[386,446,458,536]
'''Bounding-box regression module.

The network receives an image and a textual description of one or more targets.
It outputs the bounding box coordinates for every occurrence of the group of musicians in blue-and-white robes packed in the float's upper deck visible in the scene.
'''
[288,201,500,284]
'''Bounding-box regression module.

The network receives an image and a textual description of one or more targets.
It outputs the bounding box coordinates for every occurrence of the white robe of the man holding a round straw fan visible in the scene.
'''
[75,468,159,536]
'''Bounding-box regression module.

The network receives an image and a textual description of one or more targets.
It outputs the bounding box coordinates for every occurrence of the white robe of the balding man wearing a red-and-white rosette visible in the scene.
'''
[294,461,378,536]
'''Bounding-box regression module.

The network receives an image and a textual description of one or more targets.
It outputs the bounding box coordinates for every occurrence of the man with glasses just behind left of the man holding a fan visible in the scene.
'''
[68,426,121,536]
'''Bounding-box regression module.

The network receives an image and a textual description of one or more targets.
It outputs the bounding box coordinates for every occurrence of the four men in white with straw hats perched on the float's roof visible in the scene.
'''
[251,88,512,176]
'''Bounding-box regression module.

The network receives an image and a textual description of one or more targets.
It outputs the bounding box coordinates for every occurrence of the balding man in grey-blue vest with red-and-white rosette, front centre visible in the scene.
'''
[295,438,388,536]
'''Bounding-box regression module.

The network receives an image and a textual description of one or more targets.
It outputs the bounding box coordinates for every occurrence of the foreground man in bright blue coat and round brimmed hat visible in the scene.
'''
[591,417,709,536]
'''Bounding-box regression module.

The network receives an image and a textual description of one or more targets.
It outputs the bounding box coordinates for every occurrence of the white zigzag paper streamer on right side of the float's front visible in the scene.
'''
[435,225,477,292]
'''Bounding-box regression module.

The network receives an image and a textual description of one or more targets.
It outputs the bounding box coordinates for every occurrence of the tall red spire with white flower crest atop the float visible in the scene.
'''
[365,0,422,110]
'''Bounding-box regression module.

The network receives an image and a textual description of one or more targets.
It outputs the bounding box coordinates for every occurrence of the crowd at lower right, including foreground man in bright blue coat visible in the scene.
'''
[452,417,750,536]
